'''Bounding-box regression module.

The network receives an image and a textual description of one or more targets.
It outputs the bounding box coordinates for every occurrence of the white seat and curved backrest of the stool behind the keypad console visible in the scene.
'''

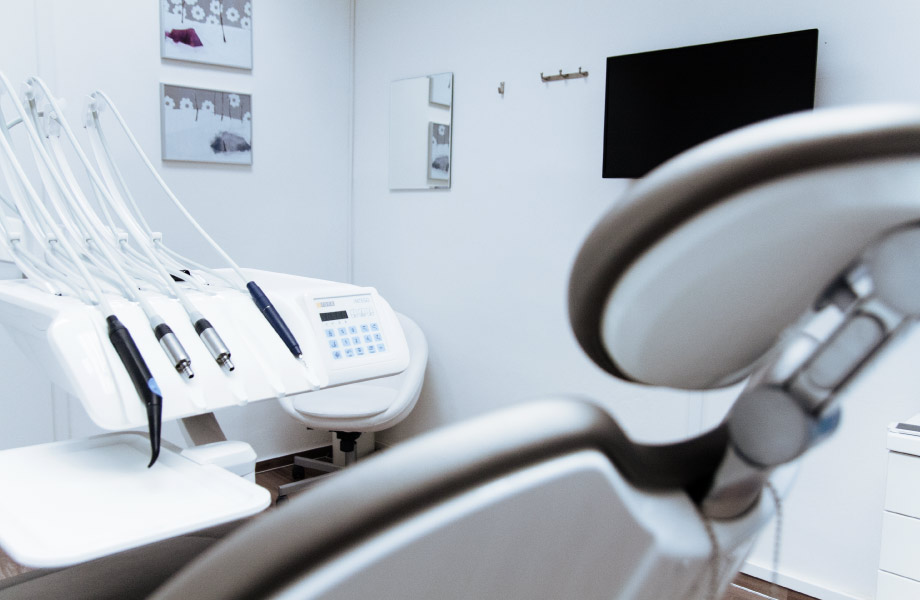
[281,313,428,432]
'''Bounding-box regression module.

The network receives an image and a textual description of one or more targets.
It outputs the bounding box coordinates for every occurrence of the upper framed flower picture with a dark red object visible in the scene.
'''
[159,0,253,69]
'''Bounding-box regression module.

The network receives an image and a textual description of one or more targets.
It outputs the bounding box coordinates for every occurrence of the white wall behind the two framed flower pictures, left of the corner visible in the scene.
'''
[0,0,351,458]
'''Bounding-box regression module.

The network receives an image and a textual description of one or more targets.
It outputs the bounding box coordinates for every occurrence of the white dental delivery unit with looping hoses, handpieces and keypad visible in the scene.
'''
[0,73,417,566]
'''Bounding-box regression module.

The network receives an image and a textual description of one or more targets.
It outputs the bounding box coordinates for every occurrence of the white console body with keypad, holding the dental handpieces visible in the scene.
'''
[0,270,409,431]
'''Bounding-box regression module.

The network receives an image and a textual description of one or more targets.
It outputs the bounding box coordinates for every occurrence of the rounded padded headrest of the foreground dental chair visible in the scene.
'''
[569,105,920,389]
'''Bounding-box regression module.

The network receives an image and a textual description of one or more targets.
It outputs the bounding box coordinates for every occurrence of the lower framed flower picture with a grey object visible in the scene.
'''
[160,84,252,165]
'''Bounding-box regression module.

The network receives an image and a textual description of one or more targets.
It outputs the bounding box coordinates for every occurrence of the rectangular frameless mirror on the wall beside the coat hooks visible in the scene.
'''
[389,73,454,190]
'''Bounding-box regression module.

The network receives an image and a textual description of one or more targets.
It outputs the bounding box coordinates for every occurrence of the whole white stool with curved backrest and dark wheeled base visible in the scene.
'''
[278,313,428,501]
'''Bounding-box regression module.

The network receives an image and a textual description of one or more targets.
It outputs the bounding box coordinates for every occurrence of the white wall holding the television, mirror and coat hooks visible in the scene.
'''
[354,0,920,598]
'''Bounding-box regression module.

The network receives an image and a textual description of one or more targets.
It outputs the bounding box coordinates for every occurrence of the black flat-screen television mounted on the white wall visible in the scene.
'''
[603,29,818,177]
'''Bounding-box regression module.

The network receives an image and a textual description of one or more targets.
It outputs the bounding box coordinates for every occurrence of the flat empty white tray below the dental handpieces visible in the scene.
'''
[0,433,271,567]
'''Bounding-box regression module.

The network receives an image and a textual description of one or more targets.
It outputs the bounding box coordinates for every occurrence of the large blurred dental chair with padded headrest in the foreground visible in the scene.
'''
[0,107,920,600]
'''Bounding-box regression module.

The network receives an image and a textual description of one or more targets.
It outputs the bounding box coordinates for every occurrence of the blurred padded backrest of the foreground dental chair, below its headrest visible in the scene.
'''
[153,399,748,600]
